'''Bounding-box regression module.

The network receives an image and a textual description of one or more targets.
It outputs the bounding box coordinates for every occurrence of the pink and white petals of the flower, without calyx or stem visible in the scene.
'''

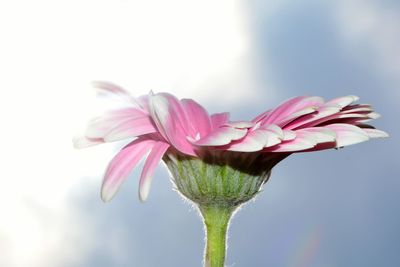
[74,82,388,201]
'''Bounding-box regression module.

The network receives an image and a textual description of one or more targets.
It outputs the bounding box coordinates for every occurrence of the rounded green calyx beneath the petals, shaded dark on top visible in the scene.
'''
[163,151,282,207]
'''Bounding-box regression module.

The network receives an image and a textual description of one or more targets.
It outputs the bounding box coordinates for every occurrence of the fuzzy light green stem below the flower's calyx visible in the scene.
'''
[200,204,235,267]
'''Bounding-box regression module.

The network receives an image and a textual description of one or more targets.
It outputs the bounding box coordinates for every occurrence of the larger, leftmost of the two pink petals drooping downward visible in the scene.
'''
[101,138,155,202]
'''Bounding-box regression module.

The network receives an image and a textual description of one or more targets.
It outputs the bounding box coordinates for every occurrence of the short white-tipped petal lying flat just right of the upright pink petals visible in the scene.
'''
[194,126,247,146]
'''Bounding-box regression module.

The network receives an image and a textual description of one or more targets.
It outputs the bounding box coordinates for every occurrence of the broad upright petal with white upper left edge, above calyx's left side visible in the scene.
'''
[149,93,196,156]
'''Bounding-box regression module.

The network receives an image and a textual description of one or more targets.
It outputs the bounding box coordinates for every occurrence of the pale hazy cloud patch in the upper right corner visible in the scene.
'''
[334,0,400,80]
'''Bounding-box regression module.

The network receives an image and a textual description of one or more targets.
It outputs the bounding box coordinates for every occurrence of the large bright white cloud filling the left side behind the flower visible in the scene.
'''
[0,0,272,267]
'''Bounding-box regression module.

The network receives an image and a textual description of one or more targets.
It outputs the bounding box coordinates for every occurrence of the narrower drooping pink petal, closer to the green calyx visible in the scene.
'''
[139,142,169,202]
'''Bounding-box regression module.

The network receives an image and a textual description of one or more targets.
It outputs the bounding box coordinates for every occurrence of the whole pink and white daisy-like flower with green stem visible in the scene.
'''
[74,82,388,267]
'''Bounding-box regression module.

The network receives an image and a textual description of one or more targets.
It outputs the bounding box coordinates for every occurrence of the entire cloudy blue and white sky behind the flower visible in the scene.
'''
[0,0,400,267]
